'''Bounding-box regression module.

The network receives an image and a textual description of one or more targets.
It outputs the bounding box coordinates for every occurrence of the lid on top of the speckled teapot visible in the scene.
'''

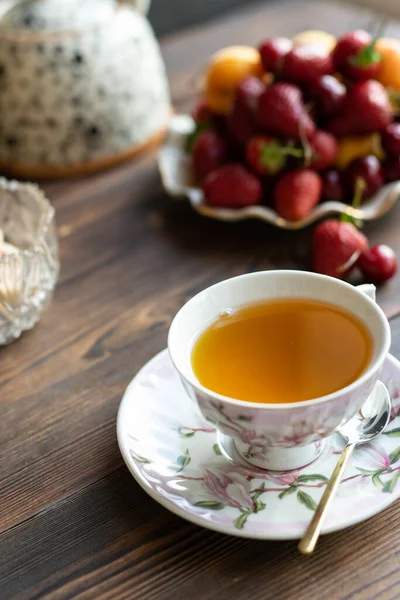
[0,0,117,33]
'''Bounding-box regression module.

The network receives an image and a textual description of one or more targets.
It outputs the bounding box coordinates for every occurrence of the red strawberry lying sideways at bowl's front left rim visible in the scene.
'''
[203,163,262,208]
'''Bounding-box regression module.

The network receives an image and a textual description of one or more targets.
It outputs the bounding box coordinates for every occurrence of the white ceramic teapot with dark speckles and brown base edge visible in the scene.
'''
[0,0,171,178]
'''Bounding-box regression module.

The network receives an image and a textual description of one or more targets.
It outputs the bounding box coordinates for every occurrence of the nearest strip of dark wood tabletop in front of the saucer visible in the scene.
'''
[0,450,400,600]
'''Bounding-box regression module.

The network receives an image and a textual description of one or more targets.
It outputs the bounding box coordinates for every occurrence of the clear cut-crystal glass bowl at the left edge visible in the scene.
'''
[0,177,59,345]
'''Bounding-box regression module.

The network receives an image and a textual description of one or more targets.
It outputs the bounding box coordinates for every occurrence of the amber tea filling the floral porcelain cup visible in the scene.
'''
[191,298,372,403]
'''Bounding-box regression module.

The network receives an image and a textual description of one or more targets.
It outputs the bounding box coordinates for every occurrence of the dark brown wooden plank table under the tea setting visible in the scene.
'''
[0,0,400,600]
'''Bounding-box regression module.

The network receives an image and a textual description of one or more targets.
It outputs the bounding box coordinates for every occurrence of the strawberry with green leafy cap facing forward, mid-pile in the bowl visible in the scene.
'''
[246,135,303,175]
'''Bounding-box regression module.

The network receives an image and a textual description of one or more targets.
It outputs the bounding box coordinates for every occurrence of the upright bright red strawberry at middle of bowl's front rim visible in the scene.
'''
[274,169,322,221]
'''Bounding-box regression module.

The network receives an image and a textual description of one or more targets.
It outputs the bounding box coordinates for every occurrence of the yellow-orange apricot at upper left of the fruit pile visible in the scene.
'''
[204,46,263,115]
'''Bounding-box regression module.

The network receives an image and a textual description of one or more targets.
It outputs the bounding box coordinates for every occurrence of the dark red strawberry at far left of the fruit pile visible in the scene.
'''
[192,130,227,179]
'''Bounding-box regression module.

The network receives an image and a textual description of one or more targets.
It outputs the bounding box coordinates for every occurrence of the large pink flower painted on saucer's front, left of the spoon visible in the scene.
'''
[203,468,253,508]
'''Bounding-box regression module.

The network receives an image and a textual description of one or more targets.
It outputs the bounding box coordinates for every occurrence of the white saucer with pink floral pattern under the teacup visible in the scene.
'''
[117,350,400,540]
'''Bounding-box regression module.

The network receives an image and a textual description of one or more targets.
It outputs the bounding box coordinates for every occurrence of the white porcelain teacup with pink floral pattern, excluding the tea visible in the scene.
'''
[168,270,391,470]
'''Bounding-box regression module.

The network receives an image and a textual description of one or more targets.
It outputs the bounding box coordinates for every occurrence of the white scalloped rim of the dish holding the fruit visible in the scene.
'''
[158,115,400,229]
